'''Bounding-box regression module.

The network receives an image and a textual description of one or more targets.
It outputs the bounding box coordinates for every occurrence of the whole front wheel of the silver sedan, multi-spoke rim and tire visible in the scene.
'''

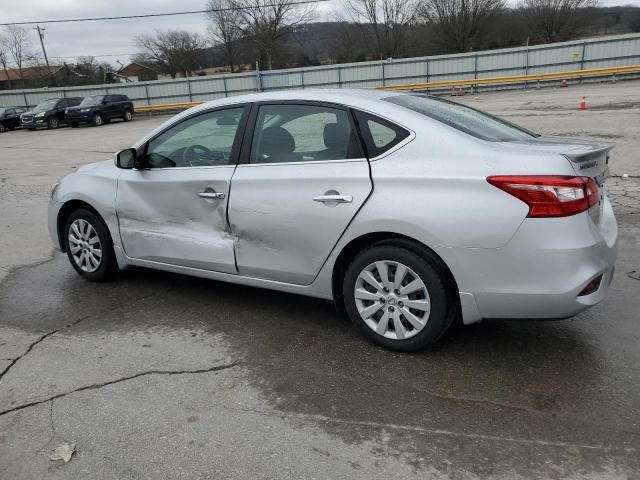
[64,210,117,281]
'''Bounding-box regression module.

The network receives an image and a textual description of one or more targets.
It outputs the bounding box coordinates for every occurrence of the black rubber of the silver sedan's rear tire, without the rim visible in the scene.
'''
[342,242,457,352]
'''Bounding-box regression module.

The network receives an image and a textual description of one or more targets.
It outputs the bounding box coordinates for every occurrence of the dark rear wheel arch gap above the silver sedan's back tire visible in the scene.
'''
[331,232,460,311]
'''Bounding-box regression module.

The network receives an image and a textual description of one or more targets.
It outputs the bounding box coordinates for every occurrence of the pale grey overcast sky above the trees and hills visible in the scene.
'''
[0,0,640,65]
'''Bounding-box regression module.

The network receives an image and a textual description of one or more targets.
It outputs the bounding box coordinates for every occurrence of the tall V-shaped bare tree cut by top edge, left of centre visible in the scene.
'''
[229,0,315,69]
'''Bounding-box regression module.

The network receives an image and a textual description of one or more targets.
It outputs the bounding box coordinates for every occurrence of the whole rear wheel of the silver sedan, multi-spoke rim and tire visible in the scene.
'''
[343,243,456,352]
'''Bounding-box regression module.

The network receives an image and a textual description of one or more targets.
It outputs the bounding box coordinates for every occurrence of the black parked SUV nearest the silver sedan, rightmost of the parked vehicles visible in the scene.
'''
[66,95,133,127]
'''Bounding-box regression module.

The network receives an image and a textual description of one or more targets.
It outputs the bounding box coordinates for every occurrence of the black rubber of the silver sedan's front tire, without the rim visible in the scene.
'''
[64,209,118,282]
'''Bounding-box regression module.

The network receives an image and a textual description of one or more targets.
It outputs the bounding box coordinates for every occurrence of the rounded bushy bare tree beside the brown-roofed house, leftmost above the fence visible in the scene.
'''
[135,30,204,78]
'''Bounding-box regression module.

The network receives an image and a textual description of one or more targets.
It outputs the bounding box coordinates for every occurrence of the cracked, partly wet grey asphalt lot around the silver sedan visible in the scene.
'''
[0,81,640,480]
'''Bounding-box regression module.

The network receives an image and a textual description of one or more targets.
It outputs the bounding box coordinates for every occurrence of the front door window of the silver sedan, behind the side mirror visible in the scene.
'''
[145,107,244,168]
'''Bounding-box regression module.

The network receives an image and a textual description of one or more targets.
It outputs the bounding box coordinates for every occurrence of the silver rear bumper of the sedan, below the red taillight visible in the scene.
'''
[446,197,618,323]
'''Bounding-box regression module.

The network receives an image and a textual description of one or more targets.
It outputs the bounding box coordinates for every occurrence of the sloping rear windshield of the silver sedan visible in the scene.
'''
[384,94,539,142]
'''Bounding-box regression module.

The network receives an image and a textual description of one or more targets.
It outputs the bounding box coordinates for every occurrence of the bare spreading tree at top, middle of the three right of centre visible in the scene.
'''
[421,0,505,52]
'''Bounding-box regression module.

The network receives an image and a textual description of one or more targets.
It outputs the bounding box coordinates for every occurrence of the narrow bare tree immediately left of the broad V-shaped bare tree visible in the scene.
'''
[207,0,242,72]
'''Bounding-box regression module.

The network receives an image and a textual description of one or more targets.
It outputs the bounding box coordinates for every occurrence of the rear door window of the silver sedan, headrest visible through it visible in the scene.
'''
[251,104,362,163]
